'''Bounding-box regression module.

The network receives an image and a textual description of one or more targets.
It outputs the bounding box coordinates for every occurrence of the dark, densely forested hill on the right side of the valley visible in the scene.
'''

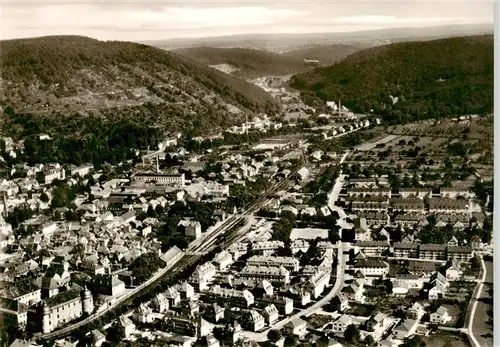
[291,35,493,122]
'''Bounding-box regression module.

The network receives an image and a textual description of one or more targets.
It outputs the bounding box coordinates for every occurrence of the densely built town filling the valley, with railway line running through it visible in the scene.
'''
[0,73,492,347]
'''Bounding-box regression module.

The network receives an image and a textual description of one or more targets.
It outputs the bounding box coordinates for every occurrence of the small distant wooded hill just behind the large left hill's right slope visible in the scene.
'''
[173,47,310,78]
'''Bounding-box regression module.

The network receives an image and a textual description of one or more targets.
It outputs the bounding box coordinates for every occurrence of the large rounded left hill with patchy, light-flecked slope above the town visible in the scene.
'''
[0,36,279,136]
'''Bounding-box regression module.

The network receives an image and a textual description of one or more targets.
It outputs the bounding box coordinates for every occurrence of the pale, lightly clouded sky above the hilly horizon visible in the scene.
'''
[0,0,493,41]
